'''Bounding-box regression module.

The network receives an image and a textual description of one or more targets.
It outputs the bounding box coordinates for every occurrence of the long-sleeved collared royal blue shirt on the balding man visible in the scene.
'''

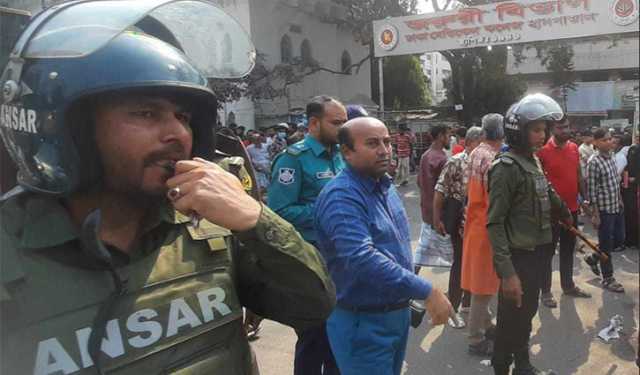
[315,167,431,307]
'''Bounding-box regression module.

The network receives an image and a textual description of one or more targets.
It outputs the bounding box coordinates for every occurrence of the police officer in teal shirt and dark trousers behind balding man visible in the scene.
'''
[267,96,347,375]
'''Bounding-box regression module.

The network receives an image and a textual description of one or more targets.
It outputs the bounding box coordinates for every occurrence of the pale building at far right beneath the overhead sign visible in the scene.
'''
[507,33,640,128]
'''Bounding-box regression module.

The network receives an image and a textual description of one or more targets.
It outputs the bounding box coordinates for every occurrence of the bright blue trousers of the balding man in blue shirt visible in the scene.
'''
[327,307,411,375]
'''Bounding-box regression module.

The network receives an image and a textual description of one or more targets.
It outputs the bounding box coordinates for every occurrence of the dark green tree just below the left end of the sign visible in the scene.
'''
[384,55,431,110]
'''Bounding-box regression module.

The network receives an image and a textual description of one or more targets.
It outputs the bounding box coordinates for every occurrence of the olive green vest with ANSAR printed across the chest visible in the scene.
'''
[0,197,251,375]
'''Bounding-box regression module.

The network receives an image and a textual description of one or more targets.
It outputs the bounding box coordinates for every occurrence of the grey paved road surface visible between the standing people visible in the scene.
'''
[252,176,639,375]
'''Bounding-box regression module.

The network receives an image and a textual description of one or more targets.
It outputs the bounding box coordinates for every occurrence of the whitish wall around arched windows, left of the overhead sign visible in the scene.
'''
[251,0,371,126]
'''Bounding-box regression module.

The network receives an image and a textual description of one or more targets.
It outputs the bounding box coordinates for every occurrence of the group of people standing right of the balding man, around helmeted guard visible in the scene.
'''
[416,99,640,374]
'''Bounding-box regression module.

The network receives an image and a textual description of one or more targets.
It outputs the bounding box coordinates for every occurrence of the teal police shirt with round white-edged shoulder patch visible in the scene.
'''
[267,135,345,242]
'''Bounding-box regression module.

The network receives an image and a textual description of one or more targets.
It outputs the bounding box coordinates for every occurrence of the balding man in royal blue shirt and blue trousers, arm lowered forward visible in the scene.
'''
[315,117,453,375]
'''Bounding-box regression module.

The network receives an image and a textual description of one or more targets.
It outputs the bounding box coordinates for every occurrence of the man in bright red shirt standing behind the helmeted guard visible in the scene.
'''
[538,117,591,307]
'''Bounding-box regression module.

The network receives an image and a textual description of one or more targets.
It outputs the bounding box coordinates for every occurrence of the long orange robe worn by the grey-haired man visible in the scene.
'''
[461,143,500,295]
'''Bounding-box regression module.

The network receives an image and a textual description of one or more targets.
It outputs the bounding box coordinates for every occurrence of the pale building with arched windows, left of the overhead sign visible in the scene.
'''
[244,0,374,127]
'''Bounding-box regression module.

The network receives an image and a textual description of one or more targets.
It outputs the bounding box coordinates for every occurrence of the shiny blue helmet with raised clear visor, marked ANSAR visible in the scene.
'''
[0,0,255,195]
